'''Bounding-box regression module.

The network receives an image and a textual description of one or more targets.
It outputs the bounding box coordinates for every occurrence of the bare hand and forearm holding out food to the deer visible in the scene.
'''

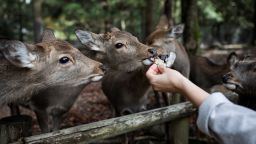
[146,64,209,107]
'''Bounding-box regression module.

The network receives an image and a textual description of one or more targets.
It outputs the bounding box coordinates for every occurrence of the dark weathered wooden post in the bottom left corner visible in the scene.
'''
[0,115,32,144]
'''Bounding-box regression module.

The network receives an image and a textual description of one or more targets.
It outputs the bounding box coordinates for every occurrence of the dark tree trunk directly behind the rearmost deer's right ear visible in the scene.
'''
[181,0,199,53]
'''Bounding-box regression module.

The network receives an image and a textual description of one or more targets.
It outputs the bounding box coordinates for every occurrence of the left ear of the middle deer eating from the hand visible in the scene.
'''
[75,30,105,53]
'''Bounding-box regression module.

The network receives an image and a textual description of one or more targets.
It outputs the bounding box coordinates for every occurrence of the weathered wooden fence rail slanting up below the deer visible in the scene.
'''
[13,102,196,144]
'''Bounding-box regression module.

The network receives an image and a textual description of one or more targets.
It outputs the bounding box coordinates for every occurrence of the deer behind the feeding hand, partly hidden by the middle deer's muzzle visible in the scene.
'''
[146,16,190,77]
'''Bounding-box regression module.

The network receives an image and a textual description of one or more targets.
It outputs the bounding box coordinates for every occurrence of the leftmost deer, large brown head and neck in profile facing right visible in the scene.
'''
[0,29,103,132]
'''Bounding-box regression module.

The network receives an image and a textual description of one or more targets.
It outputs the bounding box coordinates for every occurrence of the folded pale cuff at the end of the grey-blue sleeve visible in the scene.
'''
[197,92,231,136]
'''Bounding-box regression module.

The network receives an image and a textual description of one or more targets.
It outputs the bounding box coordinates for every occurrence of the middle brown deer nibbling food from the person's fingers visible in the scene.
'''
[76,28,176,115]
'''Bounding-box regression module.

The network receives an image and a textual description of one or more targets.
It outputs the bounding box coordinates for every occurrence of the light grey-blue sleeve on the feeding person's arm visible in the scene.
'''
[197,93,256,144]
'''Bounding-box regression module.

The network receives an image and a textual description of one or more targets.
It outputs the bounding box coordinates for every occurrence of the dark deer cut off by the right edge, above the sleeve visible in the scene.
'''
[222,53,256,110]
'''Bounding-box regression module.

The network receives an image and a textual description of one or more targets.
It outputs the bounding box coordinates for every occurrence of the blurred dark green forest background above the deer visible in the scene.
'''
[0,0,256,52]
